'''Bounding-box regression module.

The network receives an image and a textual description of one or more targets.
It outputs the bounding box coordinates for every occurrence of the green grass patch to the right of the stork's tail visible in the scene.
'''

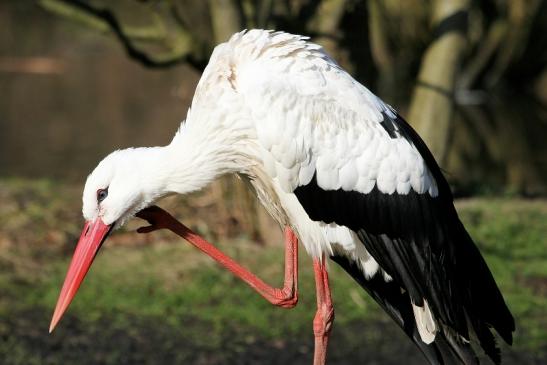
[459,199,547,353]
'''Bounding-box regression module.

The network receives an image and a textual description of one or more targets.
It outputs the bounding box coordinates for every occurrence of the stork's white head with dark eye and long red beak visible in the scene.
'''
[50,148,166,332]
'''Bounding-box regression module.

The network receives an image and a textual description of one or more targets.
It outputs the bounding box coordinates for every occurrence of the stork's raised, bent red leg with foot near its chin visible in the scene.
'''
[137,206,298,308]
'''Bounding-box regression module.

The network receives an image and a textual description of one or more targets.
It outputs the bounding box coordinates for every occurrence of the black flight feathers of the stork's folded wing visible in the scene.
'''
[294,114,515,363]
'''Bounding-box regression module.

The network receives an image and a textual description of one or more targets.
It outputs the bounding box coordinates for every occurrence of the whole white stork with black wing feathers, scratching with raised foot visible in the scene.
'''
[50,30,515,365]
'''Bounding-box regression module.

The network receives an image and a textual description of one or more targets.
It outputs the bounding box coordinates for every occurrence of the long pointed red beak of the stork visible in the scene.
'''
[49,218,113,333]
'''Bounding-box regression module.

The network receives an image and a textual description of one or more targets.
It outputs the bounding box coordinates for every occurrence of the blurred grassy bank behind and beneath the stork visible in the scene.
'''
[0,180,547,364]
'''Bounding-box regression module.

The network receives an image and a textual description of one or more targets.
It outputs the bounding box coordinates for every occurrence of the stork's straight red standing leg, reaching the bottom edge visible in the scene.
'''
[313,254,334,365]
